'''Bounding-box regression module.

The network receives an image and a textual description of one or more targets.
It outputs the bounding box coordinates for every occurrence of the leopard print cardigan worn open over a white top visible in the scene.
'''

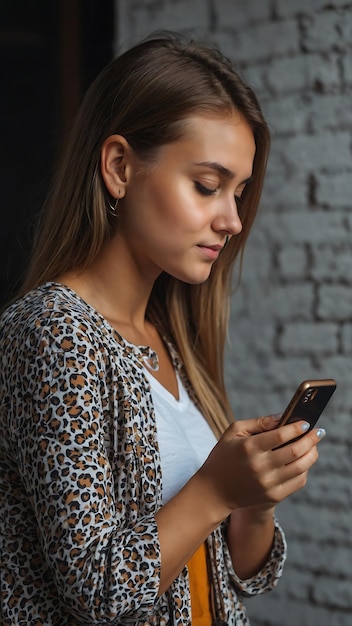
[0,283,285,626]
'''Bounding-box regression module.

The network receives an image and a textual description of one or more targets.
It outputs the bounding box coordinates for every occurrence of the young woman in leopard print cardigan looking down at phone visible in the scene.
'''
[0,35,324,626]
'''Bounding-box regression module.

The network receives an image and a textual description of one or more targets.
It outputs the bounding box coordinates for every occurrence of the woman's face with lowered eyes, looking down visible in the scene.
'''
[115,114,255,284]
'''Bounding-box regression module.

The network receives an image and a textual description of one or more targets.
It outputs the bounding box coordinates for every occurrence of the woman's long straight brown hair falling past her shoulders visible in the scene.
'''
[22,33,270,434]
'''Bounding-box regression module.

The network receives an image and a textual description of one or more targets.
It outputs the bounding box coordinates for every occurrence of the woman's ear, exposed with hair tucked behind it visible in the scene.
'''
[100,135,131,199]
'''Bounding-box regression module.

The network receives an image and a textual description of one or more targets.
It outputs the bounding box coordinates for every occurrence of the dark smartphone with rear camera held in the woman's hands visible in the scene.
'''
[278,378,336,447]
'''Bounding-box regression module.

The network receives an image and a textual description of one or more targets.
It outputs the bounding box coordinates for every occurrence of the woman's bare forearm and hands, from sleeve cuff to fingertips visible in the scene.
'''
[155,417,321,593]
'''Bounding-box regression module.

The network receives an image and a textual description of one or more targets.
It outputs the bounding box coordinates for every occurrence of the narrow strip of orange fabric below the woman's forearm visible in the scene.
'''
[187,543,213,626]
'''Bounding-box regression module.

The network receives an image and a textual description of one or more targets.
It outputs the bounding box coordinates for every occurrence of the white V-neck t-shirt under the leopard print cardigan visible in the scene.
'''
[146,369,217,504]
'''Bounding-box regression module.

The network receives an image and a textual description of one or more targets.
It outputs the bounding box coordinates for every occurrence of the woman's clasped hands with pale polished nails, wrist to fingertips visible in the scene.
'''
[195,416,325,517]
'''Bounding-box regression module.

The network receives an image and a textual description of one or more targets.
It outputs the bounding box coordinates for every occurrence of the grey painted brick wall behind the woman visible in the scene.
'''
[116,0,352,626]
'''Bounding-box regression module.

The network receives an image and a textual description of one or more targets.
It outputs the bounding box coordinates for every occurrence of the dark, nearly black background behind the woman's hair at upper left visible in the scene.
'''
[0,0,115,306]
